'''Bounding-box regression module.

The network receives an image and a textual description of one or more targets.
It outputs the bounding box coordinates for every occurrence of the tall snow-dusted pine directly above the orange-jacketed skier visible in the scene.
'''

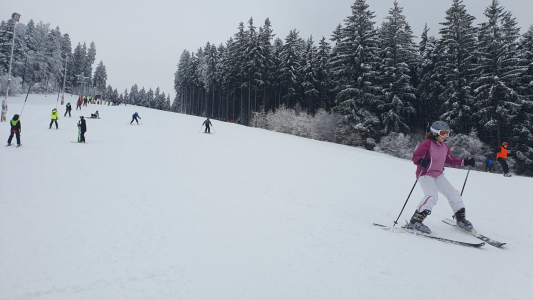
[475,0,526,146]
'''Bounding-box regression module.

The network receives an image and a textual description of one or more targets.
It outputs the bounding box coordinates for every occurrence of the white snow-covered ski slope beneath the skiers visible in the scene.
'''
[0,95,533,300]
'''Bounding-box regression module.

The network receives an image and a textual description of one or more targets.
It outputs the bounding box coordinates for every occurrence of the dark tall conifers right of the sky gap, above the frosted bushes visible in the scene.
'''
[172,0,533,175]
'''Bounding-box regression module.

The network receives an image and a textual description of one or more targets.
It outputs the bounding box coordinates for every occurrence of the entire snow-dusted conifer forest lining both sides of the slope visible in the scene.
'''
[0,0,533,176]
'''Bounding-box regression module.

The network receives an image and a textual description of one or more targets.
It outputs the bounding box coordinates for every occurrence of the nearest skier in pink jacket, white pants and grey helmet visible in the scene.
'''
[407,121,476,234]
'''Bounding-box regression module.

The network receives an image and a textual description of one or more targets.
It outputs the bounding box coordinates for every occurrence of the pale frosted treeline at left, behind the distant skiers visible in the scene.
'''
[0,19,170,110]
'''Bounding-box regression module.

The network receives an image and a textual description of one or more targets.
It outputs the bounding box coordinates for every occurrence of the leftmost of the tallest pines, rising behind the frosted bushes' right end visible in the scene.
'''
[331,0,380,148]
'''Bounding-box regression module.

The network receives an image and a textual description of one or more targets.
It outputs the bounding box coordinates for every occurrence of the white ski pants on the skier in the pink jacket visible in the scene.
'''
[417,174,465,213]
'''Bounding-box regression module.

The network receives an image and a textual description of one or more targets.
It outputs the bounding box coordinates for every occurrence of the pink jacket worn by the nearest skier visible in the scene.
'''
[413,139,464,178]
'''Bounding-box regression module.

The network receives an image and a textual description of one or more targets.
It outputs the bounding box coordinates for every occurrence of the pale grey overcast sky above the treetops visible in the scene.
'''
[0,0,533,100]
